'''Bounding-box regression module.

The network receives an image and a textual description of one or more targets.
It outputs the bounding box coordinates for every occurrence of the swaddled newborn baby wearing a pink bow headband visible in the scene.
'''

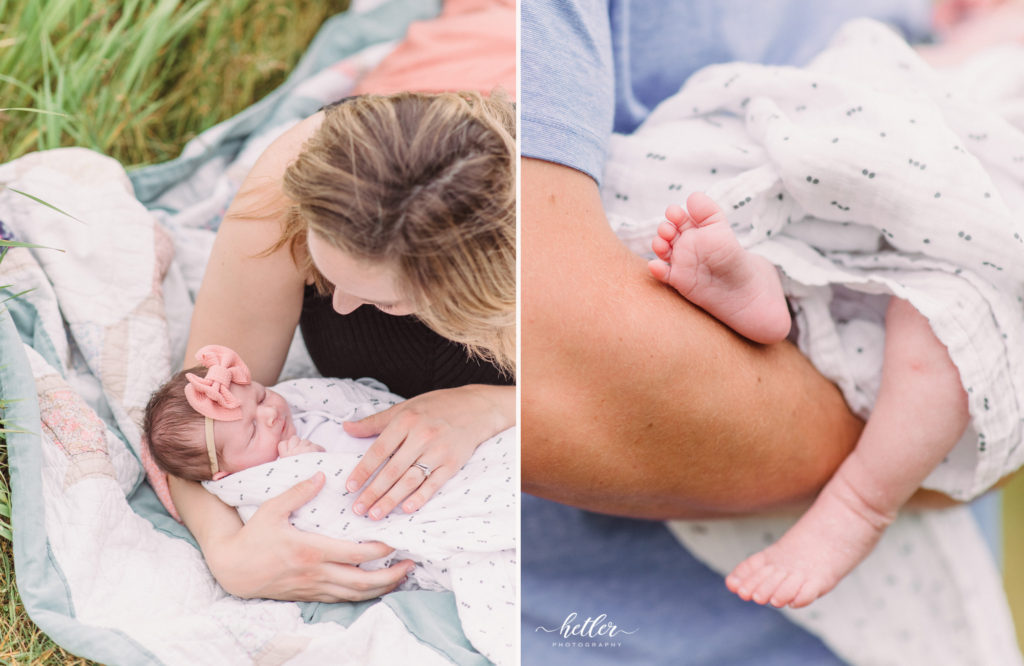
[143,345,518,663]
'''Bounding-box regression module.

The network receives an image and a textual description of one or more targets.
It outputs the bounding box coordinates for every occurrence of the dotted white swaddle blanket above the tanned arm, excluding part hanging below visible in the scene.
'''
[603,22,1024,499]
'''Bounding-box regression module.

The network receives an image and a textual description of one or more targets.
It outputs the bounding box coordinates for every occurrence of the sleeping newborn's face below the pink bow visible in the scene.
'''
[213,381,295,474]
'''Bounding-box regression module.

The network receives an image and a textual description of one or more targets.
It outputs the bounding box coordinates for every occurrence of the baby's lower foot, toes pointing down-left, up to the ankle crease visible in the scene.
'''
[725,471,893,609]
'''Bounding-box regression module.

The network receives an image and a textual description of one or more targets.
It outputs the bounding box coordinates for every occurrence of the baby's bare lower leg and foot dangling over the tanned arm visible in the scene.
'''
[725,297,970,608]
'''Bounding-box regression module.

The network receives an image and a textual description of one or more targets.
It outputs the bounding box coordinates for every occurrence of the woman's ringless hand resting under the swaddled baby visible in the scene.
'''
[190,472,413,602]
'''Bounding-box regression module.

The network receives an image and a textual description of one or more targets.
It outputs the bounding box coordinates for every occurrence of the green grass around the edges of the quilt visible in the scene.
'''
[0,0,348,664]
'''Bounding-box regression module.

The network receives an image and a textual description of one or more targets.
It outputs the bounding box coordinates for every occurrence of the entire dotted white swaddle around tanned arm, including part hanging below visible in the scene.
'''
[602,20,1024,664]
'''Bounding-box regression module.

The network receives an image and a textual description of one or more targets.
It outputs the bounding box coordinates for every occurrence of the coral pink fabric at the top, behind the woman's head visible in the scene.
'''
[353,0,516,99]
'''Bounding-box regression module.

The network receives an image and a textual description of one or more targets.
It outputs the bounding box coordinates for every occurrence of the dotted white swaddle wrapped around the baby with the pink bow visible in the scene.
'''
[203,378,518,664]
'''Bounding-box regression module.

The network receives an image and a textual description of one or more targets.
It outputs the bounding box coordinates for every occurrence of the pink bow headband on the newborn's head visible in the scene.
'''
[185,344,252,474]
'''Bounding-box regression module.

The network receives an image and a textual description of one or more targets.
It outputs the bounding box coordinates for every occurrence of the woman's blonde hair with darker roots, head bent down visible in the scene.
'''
[274,92,516,374]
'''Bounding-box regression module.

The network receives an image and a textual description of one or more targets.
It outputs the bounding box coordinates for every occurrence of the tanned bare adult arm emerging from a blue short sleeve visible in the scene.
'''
[522,160,862,518]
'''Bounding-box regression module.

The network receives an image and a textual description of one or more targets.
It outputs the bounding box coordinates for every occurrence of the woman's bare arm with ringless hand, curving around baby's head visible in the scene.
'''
[170,114,411,601]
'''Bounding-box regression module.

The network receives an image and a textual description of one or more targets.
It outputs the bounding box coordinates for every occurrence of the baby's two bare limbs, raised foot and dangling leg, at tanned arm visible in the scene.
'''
[649,193,970,608]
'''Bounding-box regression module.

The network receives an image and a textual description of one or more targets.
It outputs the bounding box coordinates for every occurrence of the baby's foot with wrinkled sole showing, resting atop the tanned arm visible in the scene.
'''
[649,192,790,344]
